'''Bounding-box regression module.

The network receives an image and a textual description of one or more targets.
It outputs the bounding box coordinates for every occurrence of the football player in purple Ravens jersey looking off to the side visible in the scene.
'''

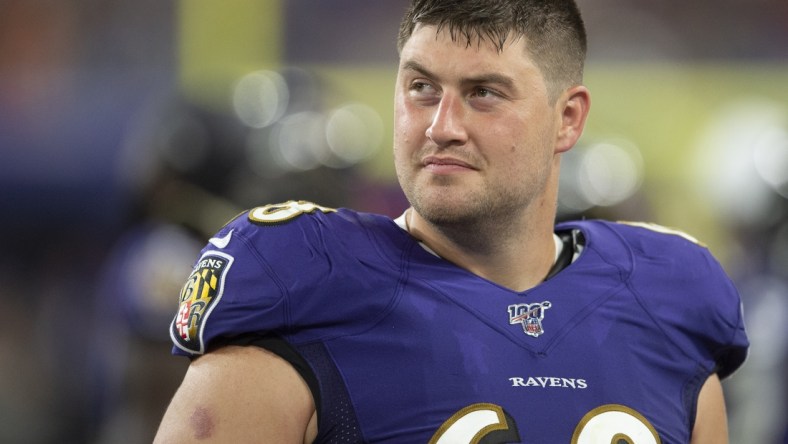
[157,0,748,444]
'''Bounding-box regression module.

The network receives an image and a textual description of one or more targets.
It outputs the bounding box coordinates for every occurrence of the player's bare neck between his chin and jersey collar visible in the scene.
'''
[405,208,555,291]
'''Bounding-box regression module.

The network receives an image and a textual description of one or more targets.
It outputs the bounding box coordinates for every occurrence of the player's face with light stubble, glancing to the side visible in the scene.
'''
[394,26,561,223]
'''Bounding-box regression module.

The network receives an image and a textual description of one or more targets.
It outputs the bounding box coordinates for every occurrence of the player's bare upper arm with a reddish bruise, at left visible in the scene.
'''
[154,346,317,444]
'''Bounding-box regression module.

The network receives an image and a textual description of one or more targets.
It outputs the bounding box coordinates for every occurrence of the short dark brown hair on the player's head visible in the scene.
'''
[397,0,587,100]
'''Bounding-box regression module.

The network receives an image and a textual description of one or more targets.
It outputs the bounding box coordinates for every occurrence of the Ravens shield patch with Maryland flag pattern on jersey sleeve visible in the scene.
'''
[170,251,233,354]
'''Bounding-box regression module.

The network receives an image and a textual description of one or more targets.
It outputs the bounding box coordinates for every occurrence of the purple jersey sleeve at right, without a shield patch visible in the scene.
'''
[619,224,749,378]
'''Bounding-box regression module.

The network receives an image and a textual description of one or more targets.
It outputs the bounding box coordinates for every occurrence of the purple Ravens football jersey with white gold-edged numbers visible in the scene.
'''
[170,202,748,444]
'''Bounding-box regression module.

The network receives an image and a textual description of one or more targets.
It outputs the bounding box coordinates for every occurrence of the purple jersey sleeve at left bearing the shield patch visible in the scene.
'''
[170,202,396,355]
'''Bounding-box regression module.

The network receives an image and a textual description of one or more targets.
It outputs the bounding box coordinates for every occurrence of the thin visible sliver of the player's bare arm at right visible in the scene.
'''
[691,373,728,444]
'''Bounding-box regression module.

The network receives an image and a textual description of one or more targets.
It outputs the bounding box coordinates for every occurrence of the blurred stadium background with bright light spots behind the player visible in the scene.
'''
[0,0,788,444]
